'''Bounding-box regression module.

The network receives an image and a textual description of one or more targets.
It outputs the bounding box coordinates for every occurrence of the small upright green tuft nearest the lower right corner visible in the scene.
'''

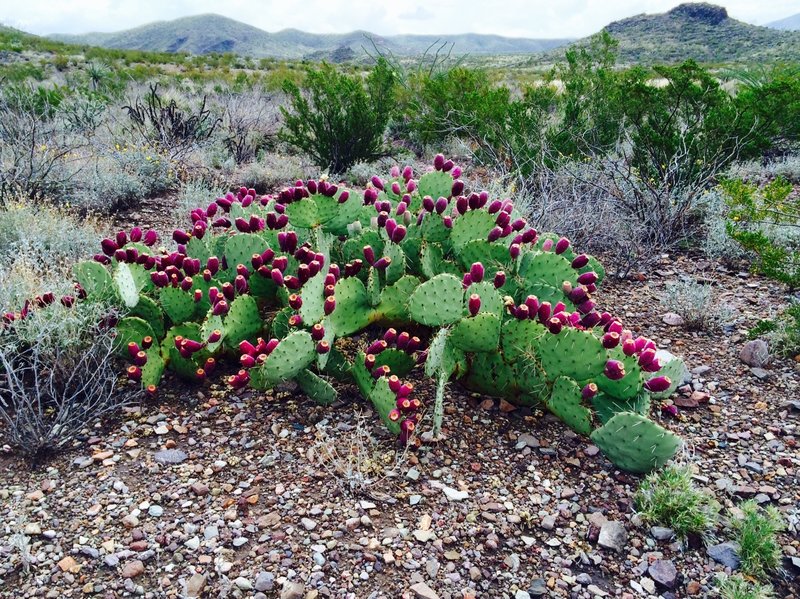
[731,500,785,580]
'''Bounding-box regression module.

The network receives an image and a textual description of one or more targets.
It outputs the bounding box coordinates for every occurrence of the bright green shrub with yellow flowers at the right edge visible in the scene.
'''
[722,177,800,289]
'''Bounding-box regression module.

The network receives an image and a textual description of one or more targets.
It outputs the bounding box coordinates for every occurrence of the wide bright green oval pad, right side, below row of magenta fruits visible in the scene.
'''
[535,328,606,381]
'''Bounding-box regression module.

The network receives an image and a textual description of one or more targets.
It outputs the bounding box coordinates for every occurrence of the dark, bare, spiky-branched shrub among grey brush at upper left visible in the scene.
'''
[123,83,220,158]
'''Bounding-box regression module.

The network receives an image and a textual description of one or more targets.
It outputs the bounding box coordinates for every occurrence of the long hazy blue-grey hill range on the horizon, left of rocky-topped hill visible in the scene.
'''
[48,14,571,59]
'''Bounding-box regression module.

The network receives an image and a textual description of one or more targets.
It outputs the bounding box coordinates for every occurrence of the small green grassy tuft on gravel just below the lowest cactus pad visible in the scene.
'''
[634,465,719,539]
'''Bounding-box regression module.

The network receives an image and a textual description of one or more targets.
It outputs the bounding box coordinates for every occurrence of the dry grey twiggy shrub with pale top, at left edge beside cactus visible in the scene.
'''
[0,301,137,458]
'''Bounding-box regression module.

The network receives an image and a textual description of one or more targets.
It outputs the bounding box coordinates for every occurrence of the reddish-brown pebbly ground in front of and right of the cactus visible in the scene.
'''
[0,258,800,599]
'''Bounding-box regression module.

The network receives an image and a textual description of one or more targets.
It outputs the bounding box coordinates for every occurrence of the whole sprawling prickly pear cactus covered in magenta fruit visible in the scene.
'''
[20,155,680,472]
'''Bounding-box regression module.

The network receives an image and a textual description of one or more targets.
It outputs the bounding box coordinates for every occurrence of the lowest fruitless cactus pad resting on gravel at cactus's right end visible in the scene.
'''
[592,412,681,474]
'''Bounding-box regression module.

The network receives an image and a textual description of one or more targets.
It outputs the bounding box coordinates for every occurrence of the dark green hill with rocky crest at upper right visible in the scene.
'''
[559,3,800,64]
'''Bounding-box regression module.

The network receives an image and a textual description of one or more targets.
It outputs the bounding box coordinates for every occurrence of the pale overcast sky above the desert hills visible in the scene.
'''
[0,0,800,38]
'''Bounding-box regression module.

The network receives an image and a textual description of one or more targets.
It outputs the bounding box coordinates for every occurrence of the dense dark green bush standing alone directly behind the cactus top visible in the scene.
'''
[279,59,396,173]
